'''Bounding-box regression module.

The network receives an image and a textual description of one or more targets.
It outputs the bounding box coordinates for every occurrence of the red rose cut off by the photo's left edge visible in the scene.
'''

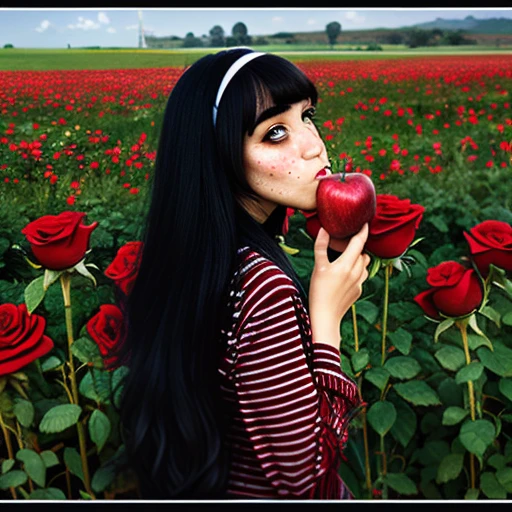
[0,303,53,375]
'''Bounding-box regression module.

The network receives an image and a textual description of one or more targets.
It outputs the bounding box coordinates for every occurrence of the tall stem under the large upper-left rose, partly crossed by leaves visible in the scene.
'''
[60,272,94,499]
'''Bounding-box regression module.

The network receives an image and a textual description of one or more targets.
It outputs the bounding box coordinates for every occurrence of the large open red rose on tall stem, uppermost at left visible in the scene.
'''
[21,212,98,270]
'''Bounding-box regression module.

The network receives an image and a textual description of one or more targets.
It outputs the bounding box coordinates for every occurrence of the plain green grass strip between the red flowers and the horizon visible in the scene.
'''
[0,45,512,71]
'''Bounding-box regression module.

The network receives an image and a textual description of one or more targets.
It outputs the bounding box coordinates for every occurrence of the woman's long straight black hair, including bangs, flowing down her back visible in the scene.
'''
[114,49,317,499]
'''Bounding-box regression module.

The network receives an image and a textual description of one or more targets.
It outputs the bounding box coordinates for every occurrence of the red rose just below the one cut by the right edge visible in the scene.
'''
[414,261,483,319]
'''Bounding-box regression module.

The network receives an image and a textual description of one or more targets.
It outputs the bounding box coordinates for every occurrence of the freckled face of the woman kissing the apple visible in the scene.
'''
[243,100,330,222]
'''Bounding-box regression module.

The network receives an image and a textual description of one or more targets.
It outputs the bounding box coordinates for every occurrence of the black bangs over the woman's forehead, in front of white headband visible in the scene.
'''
[232,54,318,135]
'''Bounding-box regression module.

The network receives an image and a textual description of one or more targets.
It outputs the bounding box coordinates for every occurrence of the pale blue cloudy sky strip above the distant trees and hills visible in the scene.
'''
[0,7,512,48]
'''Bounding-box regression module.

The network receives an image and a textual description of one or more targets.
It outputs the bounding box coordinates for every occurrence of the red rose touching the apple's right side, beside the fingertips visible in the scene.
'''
[365,194,425,259]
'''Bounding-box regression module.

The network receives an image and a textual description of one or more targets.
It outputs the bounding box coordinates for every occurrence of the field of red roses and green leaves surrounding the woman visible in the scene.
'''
[0,55,512,500]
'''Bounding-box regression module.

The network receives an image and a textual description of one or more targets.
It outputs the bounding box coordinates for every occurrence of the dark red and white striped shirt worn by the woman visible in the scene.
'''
[218,247,360,499]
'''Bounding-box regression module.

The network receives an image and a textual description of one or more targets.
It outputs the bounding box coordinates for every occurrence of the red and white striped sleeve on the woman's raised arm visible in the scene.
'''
[233,267,358,498]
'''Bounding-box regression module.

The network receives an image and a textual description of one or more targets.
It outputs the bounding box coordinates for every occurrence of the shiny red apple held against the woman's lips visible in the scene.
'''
[316,173,377,239]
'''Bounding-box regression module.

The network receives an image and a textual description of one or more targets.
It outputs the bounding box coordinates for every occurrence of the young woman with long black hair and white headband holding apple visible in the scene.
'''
[115,48,370,499]
